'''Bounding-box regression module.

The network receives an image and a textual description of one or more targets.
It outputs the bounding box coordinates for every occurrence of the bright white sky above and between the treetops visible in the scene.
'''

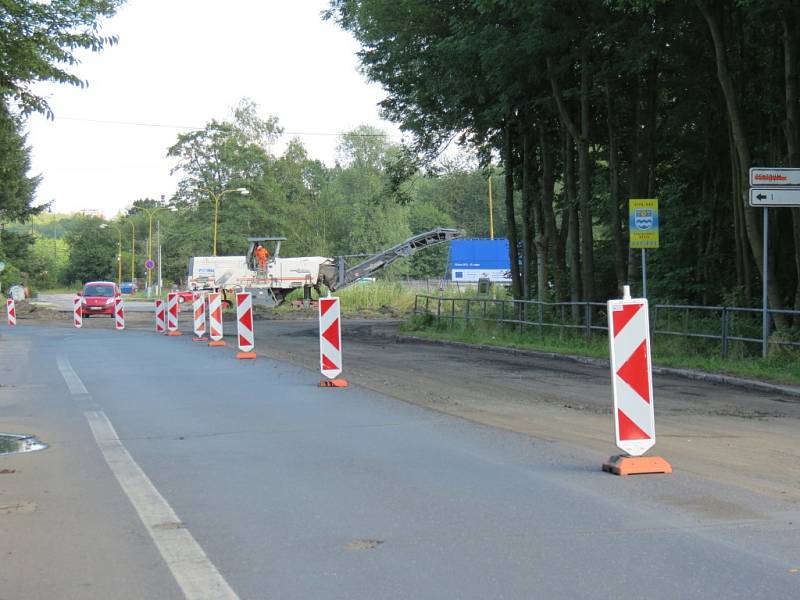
[27,0,400,218]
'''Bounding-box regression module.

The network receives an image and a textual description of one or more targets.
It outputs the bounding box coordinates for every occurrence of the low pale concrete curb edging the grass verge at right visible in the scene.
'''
[396,335,800,399]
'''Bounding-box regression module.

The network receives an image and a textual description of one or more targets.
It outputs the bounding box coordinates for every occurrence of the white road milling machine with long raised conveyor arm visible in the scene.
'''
[187,227,465,306]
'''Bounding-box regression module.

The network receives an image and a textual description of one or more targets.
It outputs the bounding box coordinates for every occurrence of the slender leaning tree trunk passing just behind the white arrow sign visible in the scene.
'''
[695,0,787,328]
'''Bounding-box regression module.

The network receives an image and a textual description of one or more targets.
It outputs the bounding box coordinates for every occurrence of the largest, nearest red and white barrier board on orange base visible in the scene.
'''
[603,285,672,475]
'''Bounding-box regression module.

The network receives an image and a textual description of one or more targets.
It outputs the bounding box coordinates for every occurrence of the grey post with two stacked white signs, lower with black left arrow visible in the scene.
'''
[750,167,800,358]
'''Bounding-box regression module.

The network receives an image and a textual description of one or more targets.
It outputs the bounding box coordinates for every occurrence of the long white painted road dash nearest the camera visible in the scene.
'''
[86,410,238,600]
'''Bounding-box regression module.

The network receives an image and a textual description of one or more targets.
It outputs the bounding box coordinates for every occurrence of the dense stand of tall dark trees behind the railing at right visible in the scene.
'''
[327,0,800,318]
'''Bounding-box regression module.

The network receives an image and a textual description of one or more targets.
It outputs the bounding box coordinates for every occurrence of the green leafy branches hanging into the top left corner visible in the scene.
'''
[0,0,124,116]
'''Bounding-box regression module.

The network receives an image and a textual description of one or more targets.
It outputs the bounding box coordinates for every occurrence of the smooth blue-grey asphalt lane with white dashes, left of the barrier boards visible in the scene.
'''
[0,324,800,600]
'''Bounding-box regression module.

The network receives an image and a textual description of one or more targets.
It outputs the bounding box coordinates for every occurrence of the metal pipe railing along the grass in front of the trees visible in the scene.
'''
[414,294,800,358]
